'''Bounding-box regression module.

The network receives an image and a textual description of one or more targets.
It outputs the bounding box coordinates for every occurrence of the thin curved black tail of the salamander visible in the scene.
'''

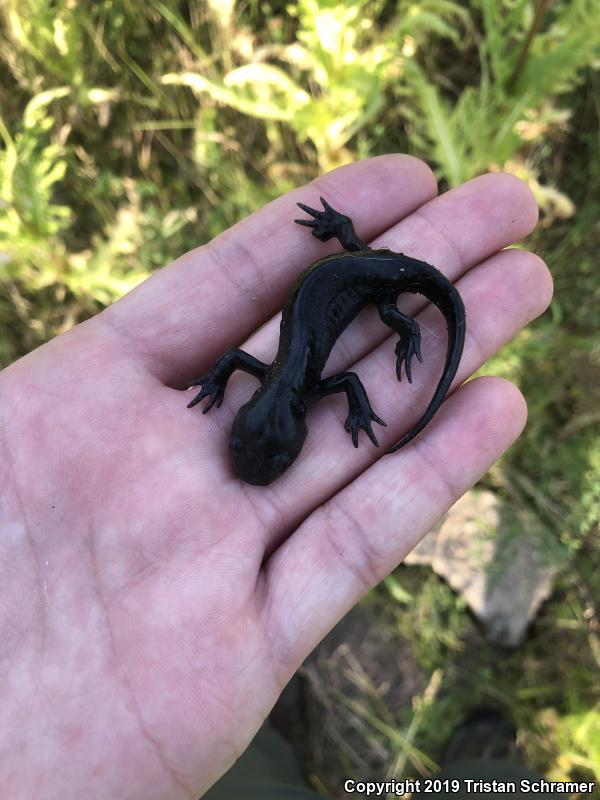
[386,270,465,453]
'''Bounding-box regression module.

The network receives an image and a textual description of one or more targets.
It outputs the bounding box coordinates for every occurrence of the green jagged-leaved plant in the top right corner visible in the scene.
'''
[408,0,600,186]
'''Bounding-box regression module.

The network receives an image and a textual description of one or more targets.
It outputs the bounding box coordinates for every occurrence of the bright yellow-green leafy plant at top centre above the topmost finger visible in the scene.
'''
[162,0,470,169]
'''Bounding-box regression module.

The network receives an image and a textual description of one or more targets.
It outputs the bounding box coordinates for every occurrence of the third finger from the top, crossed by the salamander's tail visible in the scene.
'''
[211,244,552,532]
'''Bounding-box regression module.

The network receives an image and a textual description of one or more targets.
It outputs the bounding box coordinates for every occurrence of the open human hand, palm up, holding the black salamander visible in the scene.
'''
[0,155,551,800]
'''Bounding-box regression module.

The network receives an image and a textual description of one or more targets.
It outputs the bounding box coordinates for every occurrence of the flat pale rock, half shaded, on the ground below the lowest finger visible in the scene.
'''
[407,490,557,647]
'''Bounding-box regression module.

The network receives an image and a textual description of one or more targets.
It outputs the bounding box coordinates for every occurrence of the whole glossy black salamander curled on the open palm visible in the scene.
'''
[188,198,465,486]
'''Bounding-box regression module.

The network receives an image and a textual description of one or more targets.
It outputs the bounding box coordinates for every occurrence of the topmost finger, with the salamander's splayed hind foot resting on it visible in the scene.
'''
[97,155,436,385]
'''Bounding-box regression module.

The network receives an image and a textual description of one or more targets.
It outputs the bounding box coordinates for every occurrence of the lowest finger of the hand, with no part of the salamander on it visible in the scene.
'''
[263,378,526,683]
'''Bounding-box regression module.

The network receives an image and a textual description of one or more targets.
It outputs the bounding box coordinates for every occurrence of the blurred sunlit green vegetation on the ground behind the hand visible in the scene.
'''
[0,0,600,784]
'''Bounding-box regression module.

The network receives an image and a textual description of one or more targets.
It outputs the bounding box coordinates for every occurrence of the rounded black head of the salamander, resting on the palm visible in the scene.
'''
[229,391,308,486]
